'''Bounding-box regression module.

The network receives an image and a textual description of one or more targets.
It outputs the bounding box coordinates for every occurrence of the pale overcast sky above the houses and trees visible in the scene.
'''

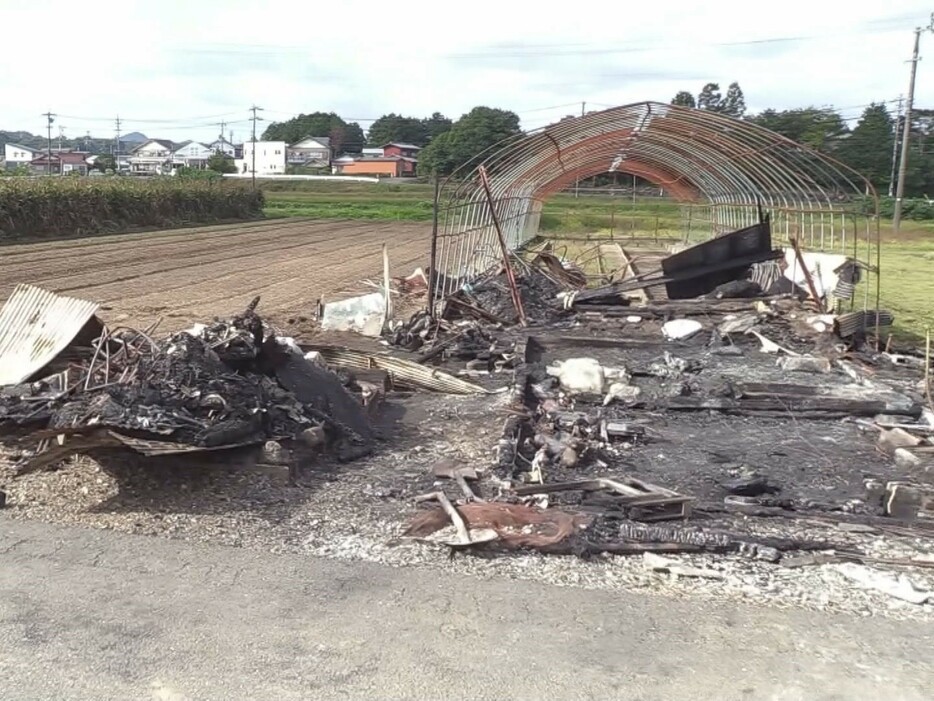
[0,0,934,141]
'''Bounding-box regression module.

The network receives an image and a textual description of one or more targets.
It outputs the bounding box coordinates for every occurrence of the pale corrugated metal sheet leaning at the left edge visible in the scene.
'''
[0,284,98,385]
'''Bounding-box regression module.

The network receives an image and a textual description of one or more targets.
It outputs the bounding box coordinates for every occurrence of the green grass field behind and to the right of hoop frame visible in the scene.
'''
[263,181,934,337]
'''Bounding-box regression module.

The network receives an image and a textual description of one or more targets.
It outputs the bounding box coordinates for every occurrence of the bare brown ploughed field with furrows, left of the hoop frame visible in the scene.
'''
[0,219,430,329]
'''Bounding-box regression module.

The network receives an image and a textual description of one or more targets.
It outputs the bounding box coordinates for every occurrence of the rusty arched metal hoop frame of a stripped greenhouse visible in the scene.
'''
[430,102,879,308]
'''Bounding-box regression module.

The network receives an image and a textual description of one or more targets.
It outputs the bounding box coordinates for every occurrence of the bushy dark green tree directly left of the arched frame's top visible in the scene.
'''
[418,107,521,175]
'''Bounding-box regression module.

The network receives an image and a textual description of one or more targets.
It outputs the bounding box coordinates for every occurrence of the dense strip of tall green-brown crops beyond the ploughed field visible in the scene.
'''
[0,177,263,243]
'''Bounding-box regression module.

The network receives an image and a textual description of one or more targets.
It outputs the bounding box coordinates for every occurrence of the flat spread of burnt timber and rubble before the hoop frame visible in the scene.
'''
[399,216,934,562]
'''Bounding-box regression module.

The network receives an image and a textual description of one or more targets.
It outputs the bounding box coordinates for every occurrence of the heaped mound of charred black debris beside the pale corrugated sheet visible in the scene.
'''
[0,298,373,470]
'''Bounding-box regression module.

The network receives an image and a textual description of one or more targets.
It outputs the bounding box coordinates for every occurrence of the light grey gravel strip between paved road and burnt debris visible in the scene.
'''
[0,388,934,619]
